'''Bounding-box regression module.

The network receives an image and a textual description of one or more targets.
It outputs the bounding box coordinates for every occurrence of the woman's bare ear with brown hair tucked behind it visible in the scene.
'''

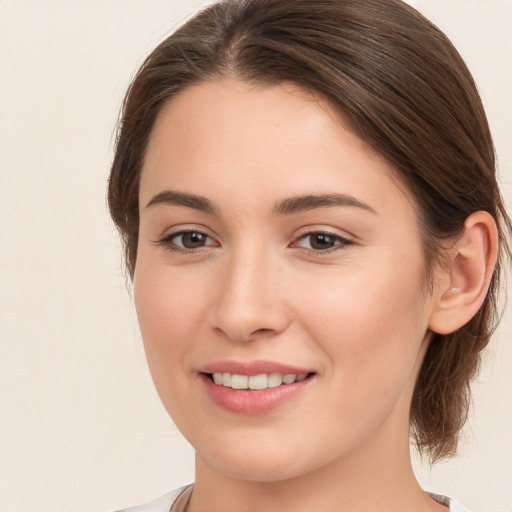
[429,211,498,334]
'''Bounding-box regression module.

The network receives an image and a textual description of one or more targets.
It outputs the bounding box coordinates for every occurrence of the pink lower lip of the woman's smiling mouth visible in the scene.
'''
[201,374,313,415]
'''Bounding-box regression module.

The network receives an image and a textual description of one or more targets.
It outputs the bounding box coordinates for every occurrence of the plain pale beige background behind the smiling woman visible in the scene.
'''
[0,0,512,512]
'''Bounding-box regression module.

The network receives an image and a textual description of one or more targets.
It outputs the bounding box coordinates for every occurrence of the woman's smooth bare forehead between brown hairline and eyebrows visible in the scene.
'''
[140,79,412,216]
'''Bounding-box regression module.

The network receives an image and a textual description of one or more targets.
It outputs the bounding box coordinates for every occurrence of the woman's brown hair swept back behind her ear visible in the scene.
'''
[108,0,511,460]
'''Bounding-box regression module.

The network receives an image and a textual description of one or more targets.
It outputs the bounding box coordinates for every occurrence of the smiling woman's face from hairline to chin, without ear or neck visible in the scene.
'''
[135,79,444,481]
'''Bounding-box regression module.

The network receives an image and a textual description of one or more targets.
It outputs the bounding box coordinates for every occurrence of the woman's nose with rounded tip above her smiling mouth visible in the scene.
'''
[214,247,290,342]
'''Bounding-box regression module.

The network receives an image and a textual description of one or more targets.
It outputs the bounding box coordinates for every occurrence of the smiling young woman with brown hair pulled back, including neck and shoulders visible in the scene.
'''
[109,0,511,512]
